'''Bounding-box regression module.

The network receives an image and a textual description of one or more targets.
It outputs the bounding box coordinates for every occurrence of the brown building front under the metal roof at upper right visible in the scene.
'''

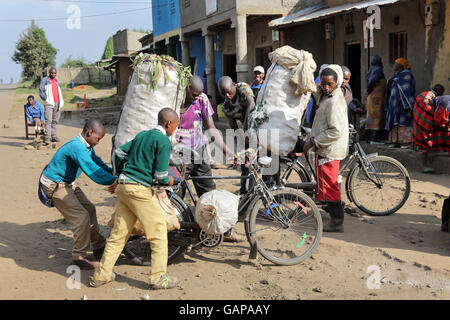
[269,0,450,99]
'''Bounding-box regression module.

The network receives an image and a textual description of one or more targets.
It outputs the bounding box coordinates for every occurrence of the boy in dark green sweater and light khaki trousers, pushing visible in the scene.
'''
[90,108,179,289]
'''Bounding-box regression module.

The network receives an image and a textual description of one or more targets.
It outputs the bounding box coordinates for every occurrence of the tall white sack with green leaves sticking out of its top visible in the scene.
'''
[112,55,190,172]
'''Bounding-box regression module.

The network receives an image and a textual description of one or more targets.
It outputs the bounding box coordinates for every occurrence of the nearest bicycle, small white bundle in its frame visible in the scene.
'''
[124,146,323,266]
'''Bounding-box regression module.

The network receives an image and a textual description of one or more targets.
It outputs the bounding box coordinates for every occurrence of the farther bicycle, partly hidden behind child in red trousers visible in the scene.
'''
[280,126,411,216]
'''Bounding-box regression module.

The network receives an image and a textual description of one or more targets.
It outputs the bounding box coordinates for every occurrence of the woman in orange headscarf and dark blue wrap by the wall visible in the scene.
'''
[385,58,416,148]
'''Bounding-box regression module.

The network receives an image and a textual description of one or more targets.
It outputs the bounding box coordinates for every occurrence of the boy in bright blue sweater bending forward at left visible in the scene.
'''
[40,120,117,270]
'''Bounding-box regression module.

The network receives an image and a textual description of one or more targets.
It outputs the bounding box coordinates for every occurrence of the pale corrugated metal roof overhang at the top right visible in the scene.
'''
[269,0,400,28]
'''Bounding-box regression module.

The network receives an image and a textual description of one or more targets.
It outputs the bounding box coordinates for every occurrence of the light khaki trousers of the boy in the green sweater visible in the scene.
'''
[94,184,168,284]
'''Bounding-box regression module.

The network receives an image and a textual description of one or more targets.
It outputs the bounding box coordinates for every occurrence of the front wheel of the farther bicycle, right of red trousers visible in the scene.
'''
[347,156,411,216]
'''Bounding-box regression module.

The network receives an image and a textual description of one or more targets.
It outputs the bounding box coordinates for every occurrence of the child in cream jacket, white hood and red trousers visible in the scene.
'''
[303,64,349,232]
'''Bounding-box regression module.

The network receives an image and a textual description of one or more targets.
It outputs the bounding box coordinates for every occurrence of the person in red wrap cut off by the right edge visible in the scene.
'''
[430,96,450,156]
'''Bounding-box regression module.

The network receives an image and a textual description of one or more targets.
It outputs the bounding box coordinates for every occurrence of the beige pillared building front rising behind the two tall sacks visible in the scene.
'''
[179,0,298,104]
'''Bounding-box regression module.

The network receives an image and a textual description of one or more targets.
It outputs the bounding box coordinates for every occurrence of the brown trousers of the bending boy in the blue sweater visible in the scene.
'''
[42,182,106,260]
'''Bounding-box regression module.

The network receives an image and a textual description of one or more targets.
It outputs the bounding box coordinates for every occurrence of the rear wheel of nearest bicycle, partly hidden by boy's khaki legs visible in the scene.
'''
[124,190,192,266]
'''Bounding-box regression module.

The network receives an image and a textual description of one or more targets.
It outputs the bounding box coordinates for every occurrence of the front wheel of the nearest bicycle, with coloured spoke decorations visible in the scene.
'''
[249,188,322,266]
